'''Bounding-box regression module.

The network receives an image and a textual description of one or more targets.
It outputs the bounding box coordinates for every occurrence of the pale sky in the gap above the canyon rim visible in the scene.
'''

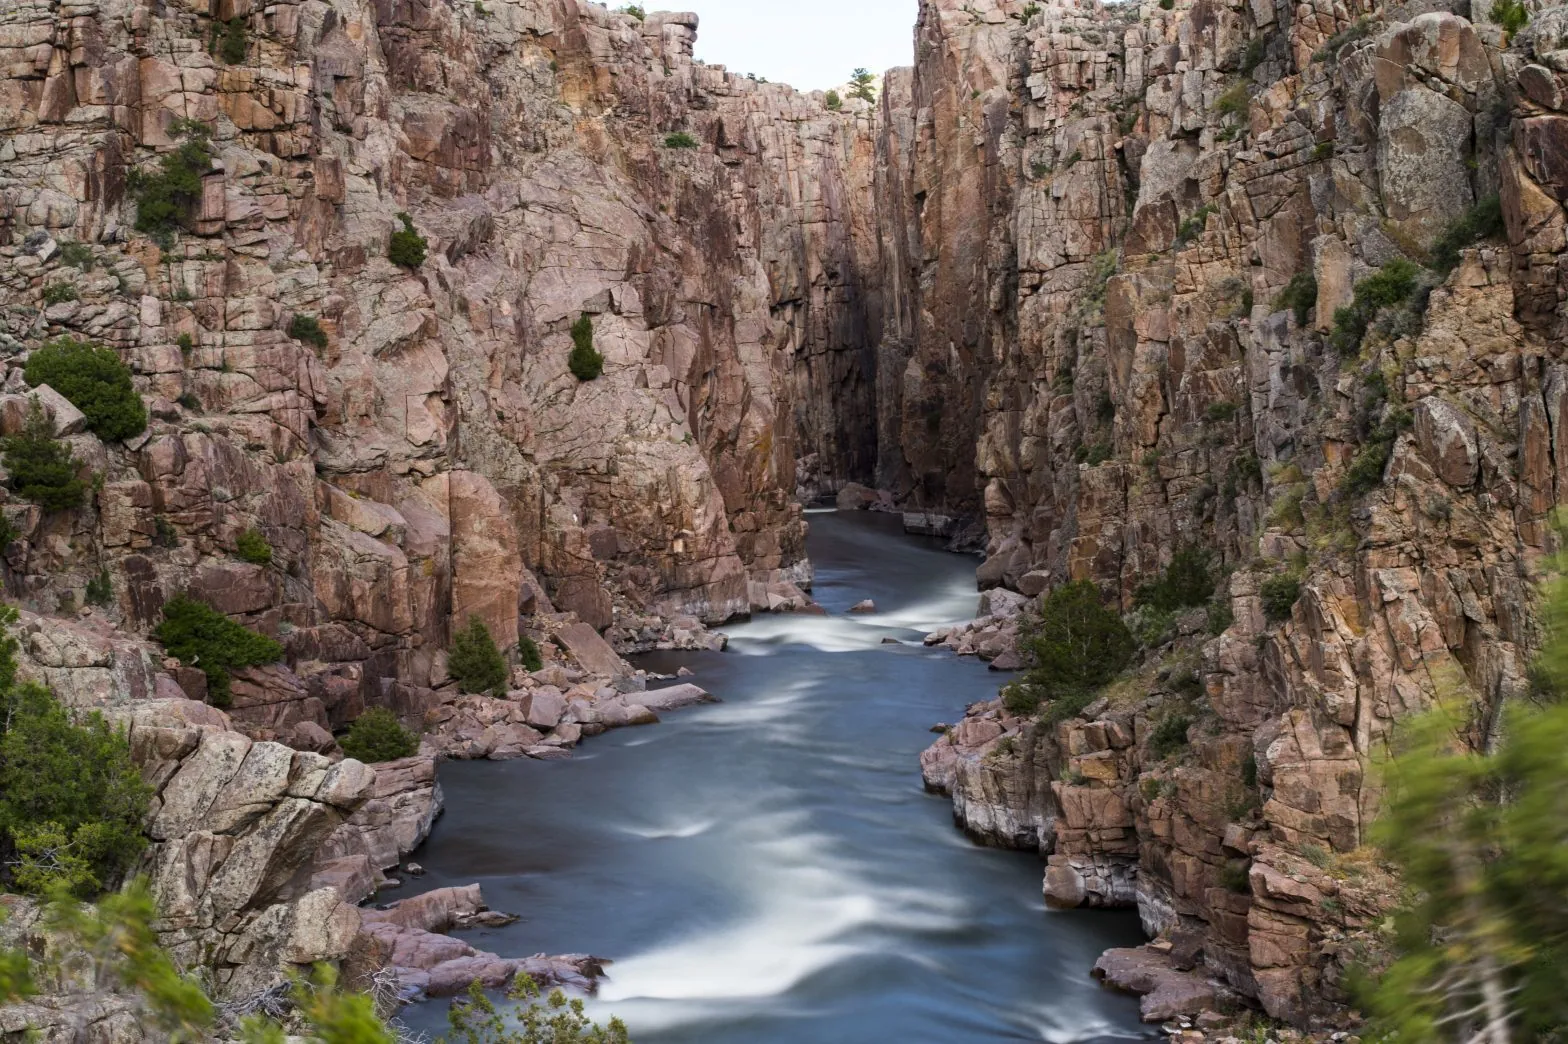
[674,0,919,91]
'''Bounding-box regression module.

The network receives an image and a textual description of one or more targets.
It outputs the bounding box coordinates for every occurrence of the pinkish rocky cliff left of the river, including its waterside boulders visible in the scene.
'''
[0,0,903,1015]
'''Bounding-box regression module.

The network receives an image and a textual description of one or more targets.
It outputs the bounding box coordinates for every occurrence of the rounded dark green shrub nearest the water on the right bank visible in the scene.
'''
[1004,580,1138,720]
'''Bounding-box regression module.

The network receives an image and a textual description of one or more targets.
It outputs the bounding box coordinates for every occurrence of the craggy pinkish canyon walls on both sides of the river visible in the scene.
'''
[0,0,1568,1039]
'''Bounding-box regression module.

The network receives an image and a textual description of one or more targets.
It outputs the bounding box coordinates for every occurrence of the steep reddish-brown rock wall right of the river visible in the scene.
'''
[909,0,1568,1024]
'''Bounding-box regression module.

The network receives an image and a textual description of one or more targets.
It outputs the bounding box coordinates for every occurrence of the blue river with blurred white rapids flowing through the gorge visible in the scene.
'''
[405,513,1146,1044]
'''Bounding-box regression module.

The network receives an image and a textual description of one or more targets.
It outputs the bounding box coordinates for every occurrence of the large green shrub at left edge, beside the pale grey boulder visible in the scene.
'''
[0,607,152,897]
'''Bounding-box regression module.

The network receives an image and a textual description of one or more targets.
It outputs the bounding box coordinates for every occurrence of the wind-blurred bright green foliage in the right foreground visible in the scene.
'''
[1366,582,1568,1044]
